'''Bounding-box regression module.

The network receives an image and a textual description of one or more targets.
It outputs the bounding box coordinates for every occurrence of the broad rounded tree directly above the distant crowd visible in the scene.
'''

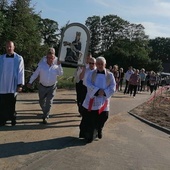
[102,16,151,69]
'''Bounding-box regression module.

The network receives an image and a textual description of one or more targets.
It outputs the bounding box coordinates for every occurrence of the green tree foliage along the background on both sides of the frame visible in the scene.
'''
[0,0,167,71]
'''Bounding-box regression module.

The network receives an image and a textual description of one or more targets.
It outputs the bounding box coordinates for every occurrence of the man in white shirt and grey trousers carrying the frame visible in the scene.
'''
[27,51,63,124]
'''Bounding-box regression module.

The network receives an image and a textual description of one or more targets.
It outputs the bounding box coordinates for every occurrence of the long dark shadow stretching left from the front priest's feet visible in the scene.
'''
[0,136,86,158]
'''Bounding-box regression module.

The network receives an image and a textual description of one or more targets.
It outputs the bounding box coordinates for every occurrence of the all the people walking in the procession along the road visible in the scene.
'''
[0,41,159,142]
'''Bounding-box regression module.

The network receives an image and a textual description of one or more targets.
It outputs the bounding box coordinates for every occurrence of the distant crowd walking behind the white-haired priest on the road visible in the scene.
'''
[109,65,161,98]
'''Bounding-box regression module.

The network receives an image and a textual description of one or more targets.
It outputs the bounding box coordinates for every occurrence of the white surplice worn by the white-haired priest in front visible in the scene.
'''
[83,69,116,111]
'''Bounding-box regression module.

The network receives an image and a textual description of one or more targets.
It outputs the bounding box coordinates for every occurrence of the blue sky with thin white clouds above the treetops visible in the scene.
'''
[31,0,170,38]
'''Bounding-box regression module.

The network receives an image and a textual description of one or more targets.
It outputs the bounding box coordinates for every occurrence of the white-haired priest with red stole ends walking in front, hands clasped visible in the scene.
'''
[79,57,116,142]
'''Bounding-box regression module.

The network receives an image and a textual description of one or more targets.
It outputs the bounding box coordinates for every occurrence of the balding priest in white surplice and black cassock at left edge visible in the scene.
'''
[0,41,24,126]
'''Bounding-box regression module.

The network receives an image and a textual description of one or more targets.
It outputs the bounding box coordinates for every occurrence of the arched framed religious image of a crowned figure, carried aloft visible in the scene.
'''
[58,23,90,66]
